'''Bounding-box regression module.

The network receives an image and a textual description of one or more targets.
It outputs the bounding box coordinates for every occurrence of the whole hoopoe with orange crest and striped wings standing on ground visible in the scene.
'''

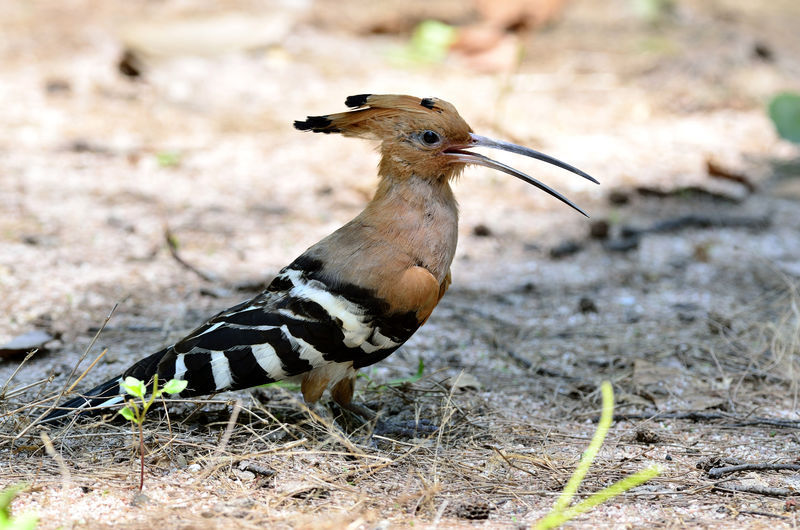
[43,94,597,422]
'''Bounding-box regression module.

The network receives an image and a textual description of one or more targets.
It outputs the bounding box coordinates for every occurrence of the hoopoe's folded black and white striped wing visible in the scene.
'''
[150,259,419,397]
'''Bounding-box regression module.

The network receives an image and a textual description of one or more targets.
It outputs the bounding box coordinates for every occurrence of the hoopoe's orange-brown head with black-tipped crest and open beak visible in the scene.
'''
[294,94,597,215]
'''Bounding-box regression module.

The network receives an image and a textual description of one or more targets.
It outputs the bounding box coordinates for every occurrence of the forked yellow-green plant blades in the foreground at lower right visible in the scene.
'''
[533,381,661,530]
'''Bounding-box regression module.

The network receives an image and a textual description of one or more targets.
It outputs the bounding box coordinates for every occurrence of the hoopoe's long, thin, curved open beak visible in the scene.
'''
[444,133,600,217]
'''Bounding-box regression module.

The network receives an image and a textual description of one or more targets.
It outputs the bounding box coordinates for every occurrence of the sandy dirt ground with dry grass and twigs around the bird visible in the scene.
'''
[0,0,800,529]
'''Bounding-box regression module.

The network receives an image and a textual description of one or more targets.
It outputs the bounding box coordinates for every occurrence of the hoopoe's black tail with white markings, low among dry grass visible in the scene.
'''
[39,349,167,424]
